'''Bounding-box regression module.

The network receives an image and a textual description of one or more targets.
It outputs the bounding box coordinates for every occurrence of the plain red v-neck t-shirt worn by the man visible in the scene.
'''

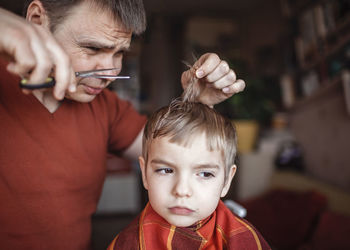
[0,62,146,250]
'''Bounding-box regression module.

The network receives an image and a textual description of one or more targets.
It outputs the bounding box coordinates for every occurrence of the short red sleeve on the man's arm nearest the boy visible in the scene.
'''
[106,91,147,153]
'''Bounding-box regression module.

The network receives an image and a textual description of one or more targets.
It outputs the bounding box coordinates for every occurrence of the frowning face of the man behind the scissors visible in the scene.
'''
[54,1,132,102]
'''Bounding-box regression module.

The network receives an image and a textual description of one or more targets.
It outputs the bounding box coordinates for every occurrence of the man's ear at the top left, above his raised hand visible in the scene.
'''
[26,0,50,28]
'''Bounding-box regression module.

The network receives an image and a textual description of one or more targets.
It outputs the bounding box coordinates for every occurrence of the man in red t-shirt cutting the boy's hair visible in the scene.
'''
[0,0,244,250]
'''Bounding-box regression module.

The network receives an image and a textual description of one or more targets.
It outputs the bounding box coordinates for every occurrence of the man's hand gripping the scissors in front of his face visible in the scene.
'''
[0,8,76,100]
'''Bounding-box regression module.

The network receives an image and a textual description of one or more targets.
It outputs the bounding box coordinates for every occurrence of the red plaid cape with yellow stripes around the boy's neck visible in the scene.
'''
[108,201,271,250]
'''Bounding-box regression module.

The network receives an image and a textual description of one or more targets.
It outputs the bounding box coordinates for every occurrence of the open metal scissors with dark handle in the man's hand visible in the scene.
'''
[19,68,130,90]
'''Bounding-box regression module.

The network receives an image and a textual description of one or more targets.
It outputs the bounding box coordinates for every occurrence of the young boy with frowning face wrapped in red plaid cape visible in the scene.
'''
[108,84,270,250]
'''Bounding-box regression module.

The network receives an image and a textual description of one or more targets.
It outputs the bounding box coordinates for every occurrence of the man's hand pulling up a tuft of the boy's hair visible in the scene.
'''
[181,53,245,107]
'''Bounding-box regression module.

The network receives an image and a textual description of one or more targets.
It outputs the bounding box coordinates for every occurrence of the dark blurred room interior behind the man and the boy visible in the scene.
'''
[1,0,350,249]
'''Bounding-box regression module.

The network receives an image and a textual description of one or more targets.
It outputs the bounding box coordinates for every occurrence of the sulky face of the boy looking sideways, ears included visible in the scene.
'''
[140,134,236,227]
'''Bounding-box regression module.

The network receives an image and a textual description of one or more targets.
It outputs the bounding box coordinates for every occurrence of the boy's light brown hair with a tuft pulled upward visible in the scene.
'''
[142,79,237,177]
